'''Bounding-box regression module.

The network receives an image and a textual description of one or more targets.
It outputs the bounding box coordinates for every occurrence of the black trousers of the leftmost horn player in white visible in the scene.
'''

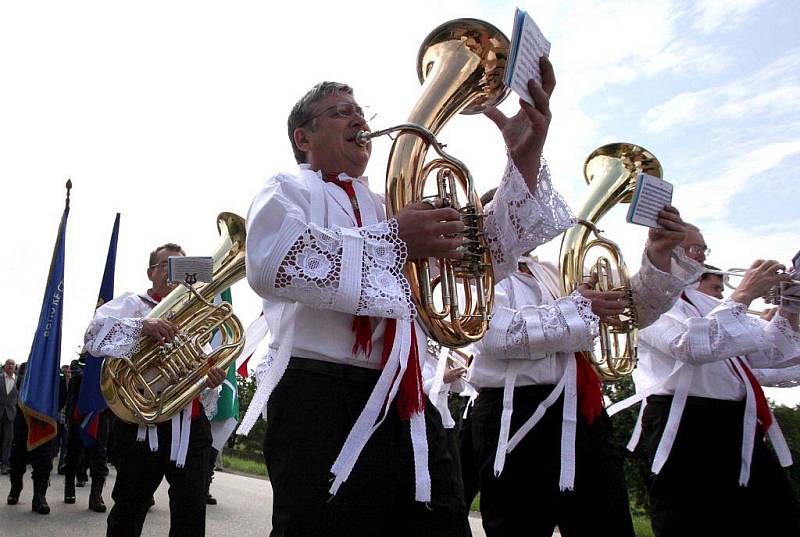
[106,413,211,537]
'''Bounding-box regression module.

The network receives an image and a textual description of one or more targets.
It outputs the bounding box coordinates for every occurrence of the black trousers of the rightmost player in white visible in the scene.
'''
[641,395,800,537]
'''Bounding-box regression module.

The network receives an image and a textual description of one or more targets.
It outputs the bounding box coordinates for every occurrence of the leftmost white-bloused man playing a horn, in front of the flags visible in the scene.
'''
[84,243,225,537]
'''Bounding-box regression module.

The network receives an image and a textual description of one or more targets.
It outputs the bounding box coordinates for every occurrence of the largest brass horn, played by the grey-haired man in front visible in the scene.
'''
[357,19,509,348]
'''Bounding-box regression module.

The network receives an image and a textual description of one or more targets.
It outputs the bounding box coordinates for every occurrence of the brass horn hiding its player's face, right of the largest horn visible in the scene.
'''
[560,143,663,382]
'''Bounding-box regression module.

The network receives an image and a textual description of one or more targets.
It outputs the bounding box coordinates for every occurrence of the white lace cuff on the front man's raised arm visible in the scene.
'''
[484,157,575,281]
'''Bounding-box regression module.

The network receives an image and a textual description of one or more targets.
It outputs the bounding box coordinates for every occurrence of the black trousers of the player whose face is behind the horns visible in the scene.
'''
[472,386,634,537]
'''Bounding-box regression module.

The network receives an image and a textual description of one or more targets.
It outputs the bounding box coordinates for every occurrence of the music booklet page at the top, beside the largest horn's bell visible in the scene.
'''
[506,8,550,104]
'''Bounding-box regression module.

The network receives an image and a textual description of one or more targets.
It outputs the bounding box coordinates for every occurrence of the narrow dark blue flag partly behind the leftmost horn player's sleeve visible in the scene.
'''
[74,213,119,446]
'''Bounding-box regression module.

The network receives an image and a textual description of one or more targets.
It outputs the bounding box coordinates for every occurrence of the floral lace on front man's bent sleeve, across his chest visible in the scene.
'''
[275,219,414,319]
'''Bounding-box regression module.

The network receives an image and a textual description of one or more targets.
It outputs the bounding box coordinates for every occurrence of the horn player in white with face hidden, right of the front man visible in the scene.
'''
[468,182,701,537]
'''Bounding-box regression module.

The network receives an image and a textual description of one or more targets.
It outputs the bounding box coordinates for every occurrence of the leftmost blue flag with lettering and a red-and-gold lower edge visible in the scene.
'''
[19,181,72,451]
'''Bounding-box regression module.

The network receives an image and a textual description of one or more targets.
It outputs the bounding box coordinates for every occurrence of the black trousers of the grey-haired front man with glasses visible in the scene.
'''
[264,358,468,537]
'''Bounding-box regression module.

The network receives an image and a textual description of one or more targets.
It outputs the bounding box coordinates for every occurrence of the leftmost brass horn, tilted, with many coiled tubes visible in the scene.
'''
[100,213,245,425]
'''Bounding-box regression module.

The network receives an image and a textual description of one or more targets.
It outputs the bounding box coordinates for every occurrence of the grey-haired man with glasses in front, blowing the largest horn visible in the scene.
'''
[240,58,571,537]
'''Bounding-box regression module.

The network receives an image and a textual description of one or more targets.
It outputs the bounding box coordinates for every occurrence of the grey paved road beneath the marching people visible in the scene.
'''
[0,467,484,537]
